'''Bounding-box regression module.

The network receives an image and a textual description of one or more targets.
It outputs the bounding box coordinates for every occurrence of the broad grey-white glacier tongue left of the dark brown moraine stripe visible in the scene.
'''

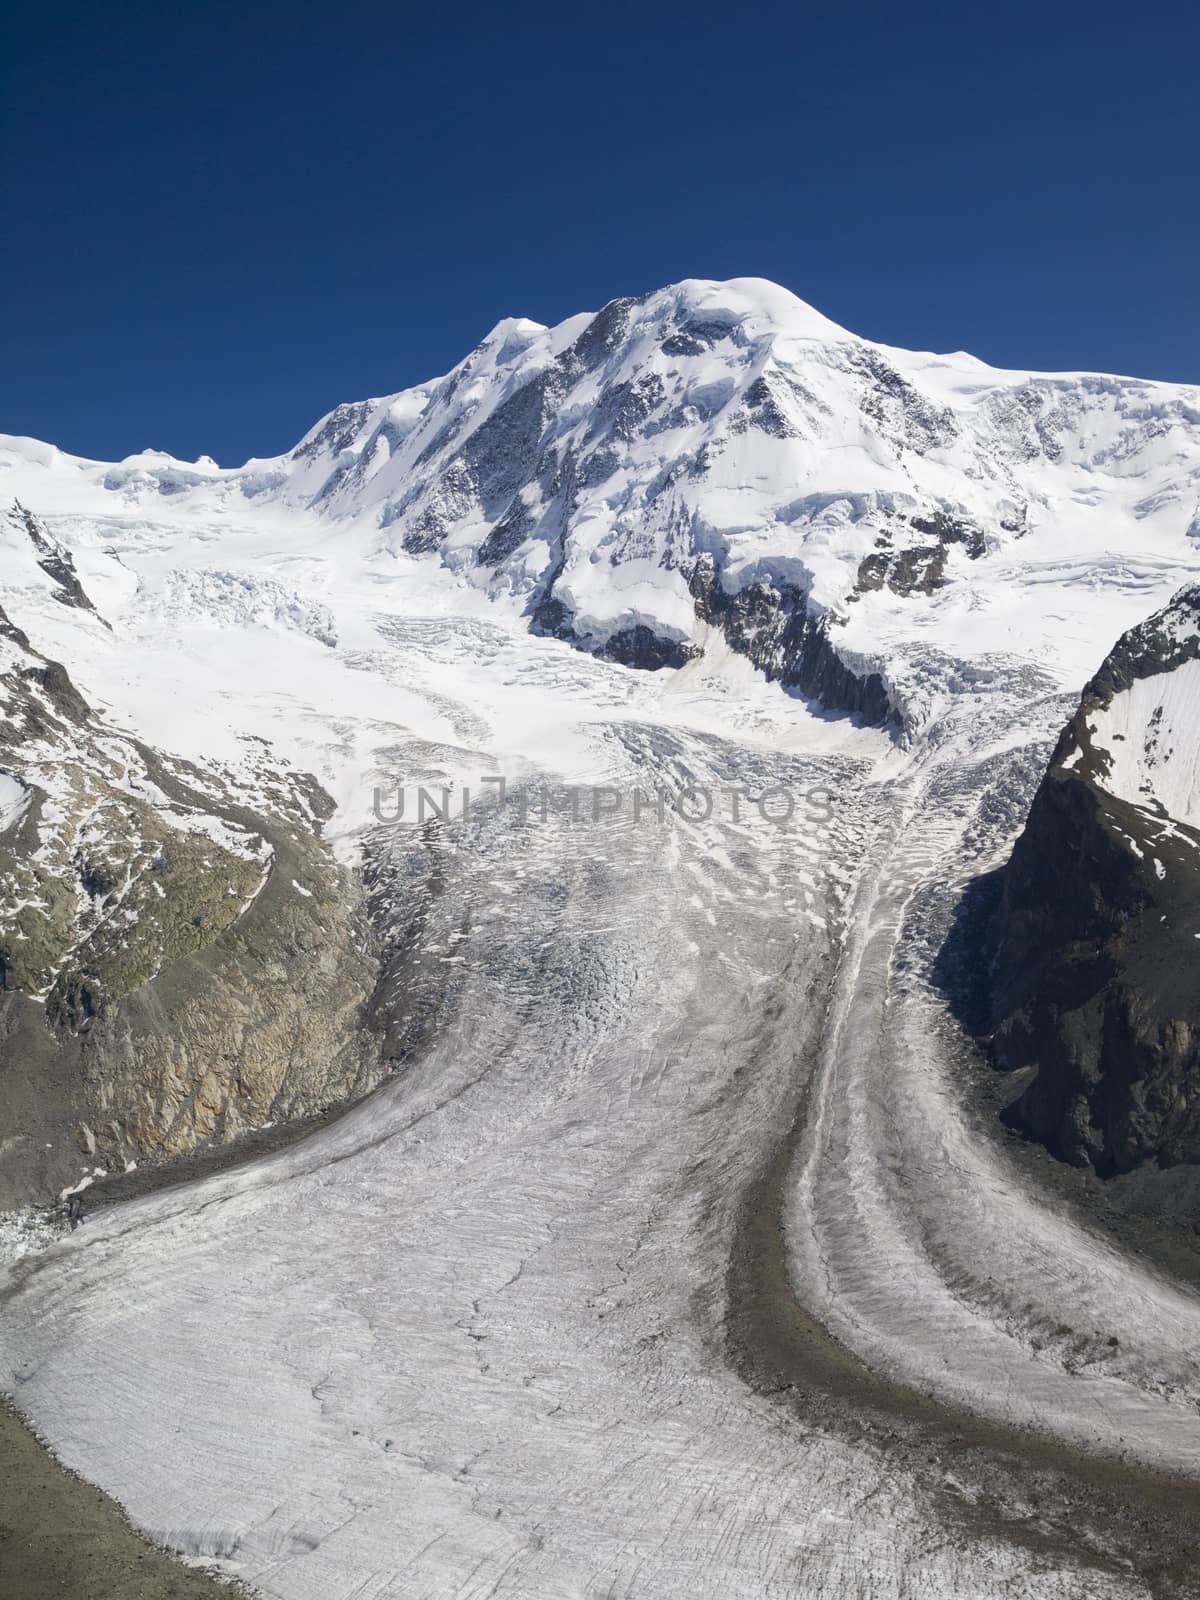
[0,652,1164,1600]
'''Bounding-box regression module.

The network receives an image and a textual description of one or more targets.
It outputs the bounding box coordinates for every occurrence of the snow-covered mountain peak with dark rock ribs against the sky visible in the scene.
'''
[0,278,1200,739]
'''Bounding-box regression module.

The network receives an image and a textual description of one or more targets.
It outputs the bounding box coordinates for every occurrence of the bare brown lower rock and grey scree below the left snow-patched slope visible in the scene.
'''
[0,850,386,1208]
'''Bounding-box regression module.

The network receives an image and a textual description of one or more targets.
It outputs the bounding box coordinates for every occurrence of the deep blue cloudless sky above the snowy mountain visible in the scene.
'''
[0,0,1200,464]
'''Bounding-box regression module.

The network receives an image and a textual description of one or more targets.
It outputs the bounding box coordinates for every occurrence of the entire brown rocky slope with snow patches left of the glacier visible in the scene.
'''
[0,613,387,1210]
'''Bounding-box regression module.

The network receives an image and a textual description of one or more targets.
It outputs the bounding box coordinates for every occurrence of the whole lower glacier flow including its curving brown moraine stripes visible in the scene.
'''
[0,622,1200,1600]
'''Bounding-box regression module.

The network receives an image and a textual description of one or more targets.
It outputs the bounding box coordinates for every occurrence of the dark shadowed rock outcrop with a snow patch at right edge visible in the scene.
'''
[992,587,1200,1174]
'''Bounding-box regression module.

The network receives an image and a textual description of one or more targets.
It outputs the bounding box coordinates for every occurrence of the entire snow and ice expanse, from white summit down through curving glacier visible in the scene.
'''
[0,278,1200,1600]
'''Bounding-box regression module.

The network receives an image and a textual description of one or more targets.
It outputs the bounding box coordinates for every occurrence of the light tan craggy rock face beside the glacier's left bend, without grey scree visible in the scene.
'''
[80,835,384,1157]
